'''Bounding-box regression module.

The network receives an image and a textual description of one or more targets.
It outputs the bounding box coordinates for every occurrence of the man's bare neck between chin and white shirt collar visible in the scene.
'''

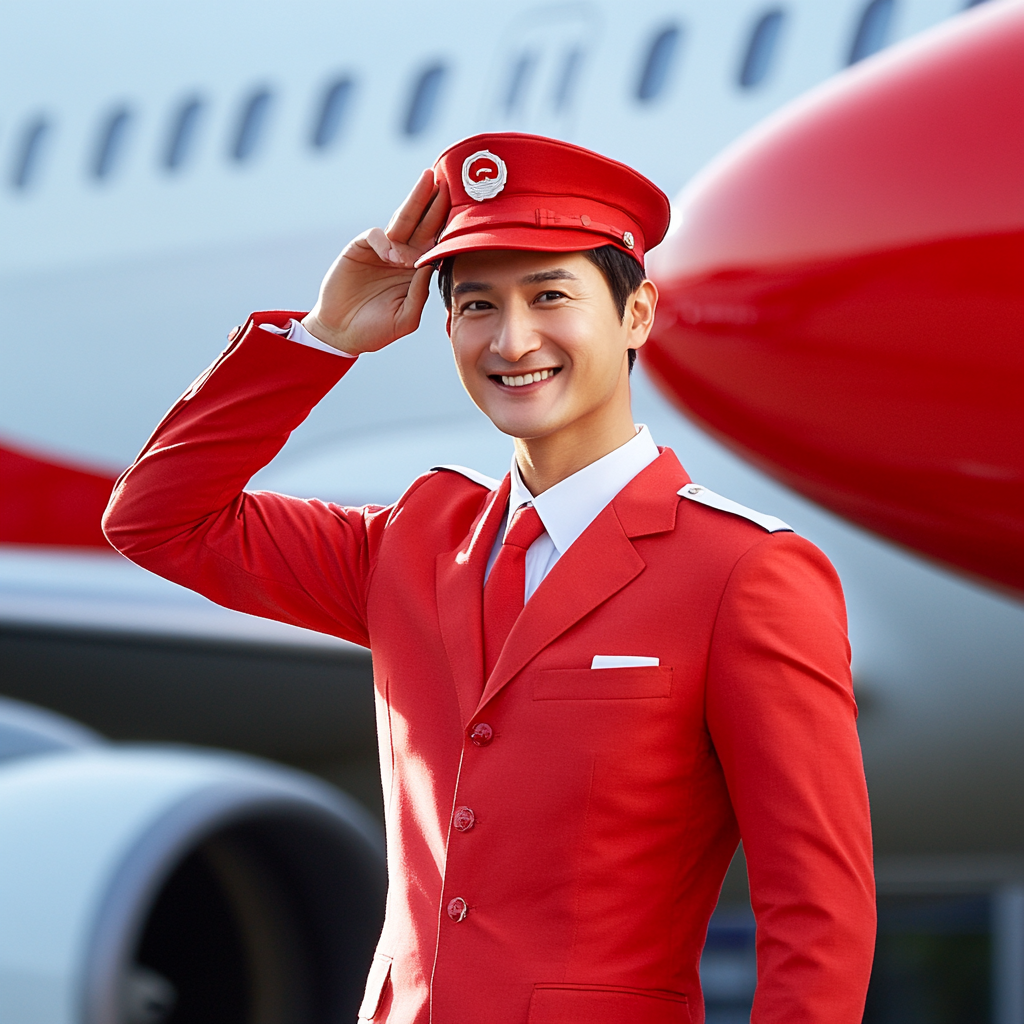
[515,391,636,496]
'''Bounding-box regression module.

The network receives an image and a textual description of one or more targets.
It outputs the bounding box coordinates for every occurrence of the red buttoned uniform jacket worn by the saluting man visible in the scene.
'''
[105,312,874,1024]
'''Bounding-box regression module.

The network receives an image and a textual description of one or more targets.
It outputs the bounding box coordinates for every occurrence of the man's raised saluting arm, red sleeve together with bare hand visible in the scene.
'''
[103,171,447,644]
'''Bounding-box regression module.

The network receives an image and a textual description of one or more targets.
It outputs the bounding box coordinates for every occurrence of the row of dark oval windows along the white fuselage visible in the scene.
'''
[9,0,983,190]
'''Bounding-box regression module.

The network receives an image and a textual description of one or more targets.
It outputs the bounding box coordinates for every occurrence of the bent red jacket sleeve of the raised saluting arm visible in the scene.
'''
[103,312,388,646]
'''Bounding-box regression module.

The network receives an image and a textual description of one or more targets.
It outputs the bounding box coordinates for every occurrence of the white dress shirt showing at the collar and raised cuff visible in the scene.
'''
[263,319,660,603]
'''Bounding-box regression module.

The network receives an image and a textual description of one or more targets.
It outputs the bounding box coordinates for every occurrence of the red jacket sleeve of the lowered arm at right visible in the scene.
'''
[707,534,876,1024]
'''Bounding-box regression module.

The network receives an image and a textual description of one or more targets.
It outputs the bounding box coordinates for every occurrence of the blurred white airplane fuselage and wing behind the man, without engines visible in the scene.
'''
[0,0,1024,1024]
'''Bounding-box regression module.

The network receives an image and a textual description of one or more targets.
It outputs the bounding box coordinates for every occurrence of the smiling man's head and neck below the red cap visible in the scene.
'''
[439,246,657,497]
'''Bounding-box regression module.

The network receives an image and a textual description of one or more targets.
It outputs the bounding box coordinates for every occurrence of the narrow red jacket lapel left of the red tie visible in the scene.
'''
[436,476,511,725]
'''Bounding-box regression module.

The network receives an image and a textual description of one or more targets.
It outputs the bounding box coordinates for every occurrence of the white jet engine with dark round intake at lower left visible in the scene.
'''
[0,700,385,1024]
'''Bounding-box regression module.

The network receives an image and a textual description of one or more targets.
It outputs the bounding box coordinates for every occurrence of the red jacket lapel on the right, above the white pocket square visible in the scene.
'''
[477,450,689,711]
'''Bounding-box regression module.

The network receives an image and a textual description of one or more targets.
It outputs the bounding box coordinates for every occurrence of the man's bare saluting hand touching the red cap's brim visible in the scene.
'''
[302,170,451,355]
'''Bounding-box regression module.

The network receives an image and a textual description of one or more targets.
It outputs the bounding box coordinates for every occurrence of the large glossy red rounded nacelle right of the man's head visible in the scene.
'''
[643,3,1024,590]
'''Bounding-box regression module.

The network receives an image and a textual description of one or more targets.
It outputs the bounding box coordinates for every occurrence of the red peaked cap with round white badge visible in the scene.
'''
[416,132,669,266]
